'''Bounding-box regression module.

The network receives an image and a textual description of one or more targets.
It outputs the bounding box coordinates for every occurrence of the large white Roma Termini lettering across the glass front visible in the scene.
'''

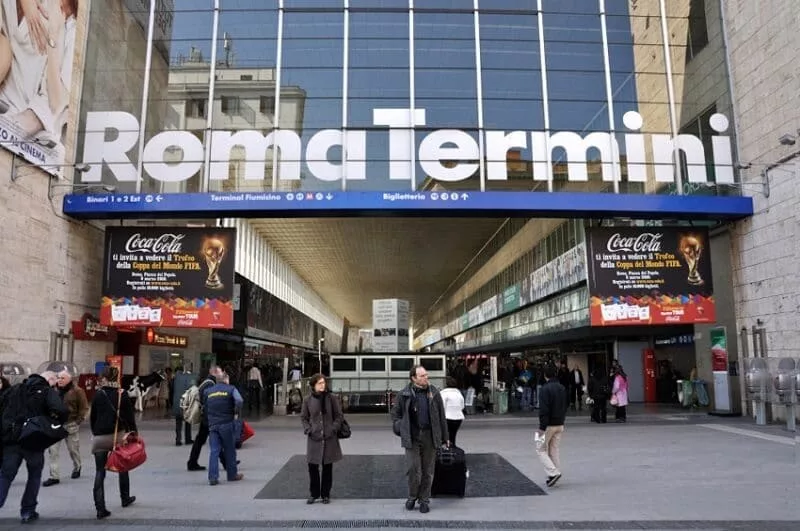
[83,109,734,184]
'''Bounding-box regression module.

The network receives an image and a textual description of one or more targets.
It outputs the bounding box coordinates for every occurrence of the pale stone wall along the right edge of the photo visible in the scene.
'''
[723,0,800,420]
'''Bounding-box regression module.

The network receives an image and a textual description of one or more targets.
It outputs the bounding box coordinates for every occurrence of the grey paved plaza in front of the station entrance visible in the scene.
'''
[0,410,800,530]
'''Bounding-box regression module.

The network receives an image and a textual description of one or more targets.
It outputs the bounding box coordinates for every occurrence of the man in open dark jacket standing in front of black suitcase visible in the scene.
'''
[392,365,449,513]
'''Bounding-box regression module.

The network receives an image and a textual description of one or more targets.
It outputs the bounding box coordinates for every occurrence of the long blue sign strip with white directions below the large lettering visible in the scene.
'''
[64,191,753,220]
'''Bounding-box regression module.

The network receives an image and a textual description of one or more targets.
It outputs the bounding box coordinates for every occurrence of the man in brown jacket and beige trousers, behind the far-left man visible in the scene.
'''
[42,369,89,487]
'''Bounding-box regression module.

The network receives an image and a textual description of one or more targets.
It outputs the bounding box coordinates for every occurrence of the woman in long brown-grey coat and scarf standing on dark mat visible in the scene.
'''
[300,374,344,505]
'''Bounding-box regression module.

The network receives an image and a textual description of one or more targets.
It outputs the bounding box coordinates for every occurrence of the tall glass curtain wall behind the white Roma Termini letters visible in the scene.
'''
[78,0,734,200]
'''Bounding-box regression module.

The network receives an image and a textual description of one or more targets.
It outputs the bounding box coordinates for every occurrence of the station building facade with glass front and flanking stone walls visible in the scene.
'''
[0,0,800,424]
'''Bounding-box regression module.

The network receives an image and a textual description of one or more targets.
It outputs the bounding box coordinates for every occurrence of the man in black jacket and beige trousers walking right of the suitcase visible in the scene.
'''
[535,365,568,487]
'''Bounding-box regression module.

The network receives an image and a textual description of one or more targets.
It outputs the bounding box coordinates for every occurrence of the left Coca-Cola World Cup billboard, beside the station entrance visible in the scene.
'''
[100,227,236,328]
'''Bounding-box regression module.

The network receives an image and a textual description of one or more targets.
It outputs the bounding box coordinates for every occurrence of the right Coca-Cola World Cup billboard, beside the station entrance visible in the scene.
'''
[586,227,716,326]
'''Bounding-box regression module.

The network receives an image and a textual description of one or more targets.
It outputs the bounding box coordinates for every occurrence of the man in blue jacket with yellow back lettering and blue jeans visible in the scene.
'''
[203,373,244,485]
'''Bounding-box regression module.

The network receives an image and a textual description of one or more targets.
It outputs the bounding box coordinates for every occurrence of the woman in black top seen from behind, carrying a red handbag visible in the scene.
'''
[90,367,136,520]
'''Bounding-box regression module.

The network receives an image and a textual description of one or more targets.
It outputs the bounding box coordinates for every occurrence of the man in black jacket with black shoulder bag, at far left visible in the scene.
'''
[0,371,69,524]
